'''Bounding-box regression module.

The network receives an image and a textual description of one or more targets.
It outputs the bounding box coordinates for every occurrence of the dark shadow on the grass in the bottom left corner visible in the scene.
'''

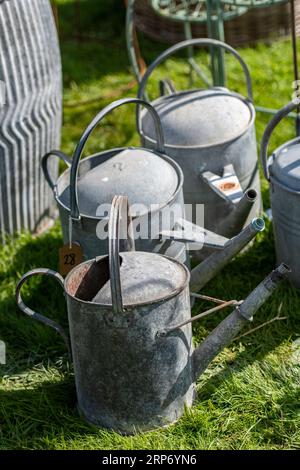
[0,377,85,449]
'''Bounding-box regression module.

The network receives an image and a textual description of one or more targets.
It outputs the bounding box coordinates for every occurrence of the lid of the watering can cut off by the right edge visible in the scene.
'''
[270,138,300,191]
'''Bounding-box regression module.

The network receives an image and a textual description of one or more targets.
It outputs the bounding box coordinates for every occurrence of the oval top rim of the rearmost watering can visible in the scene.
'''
[139,88,256,150]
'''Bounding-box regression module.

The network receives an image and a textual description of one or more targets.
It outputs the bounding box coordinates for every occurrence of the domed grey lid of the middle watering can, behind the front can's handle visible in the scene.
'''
[60,148,180,217]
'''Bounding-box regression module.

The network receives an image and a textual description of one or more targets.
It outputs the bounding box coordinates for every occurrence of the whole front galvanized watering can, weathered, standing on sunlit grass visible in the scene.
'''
[16,197,287,434]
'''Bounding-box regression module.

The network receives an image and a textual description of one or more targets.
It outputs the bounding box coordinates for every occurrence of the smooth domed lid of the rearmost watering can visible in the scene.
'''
[142,88,253,147]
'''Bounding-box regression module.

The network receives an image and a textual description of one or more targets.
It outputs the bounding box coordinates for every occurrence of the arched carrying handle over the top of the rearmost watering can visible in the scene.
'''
[138,39,253,104]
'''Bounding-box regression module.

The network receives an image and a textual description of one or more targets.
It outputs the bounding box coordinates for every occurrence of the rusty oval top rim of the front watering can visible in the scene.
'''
[64,251,190,314]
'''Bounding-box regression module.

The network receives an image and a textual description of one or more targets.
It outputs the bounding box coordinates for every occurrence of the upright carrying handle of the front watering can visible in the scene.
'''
[108,196,134,313]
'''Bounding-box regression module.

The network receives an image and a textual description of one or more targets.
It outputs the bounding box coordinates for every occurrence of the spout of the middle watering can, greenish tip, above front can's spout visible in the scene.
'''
[190,218,265,292]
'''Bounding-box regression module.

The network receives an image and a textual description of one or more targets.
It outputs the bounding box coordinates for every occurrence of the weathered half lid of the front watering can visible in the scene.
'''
[93,251,189,306]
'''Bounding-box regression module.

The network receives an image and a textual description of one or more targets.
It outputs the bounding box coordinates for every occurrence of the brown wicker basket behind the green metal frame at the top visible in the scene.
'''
[134,0,292,47]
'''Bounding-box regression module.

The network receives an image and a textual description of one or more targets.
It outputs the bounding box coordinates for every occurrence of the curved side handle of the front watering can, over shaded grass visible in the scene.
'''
[15,268,71,355]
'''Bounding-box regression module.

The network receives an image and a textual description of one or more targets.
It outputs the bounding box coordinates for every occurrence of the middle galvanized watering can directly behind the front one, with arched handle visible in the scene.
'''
[42,98,258,265]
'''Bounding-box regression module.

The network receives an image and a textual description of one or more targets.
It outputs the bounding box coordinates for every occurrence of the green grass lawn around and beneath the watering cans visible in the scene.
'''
[0,0,300,449]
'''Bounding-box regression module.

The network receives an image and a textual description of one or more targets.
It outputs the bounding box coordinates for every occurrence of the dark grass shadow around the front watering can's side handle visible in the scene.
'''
[0,226,68,375]
